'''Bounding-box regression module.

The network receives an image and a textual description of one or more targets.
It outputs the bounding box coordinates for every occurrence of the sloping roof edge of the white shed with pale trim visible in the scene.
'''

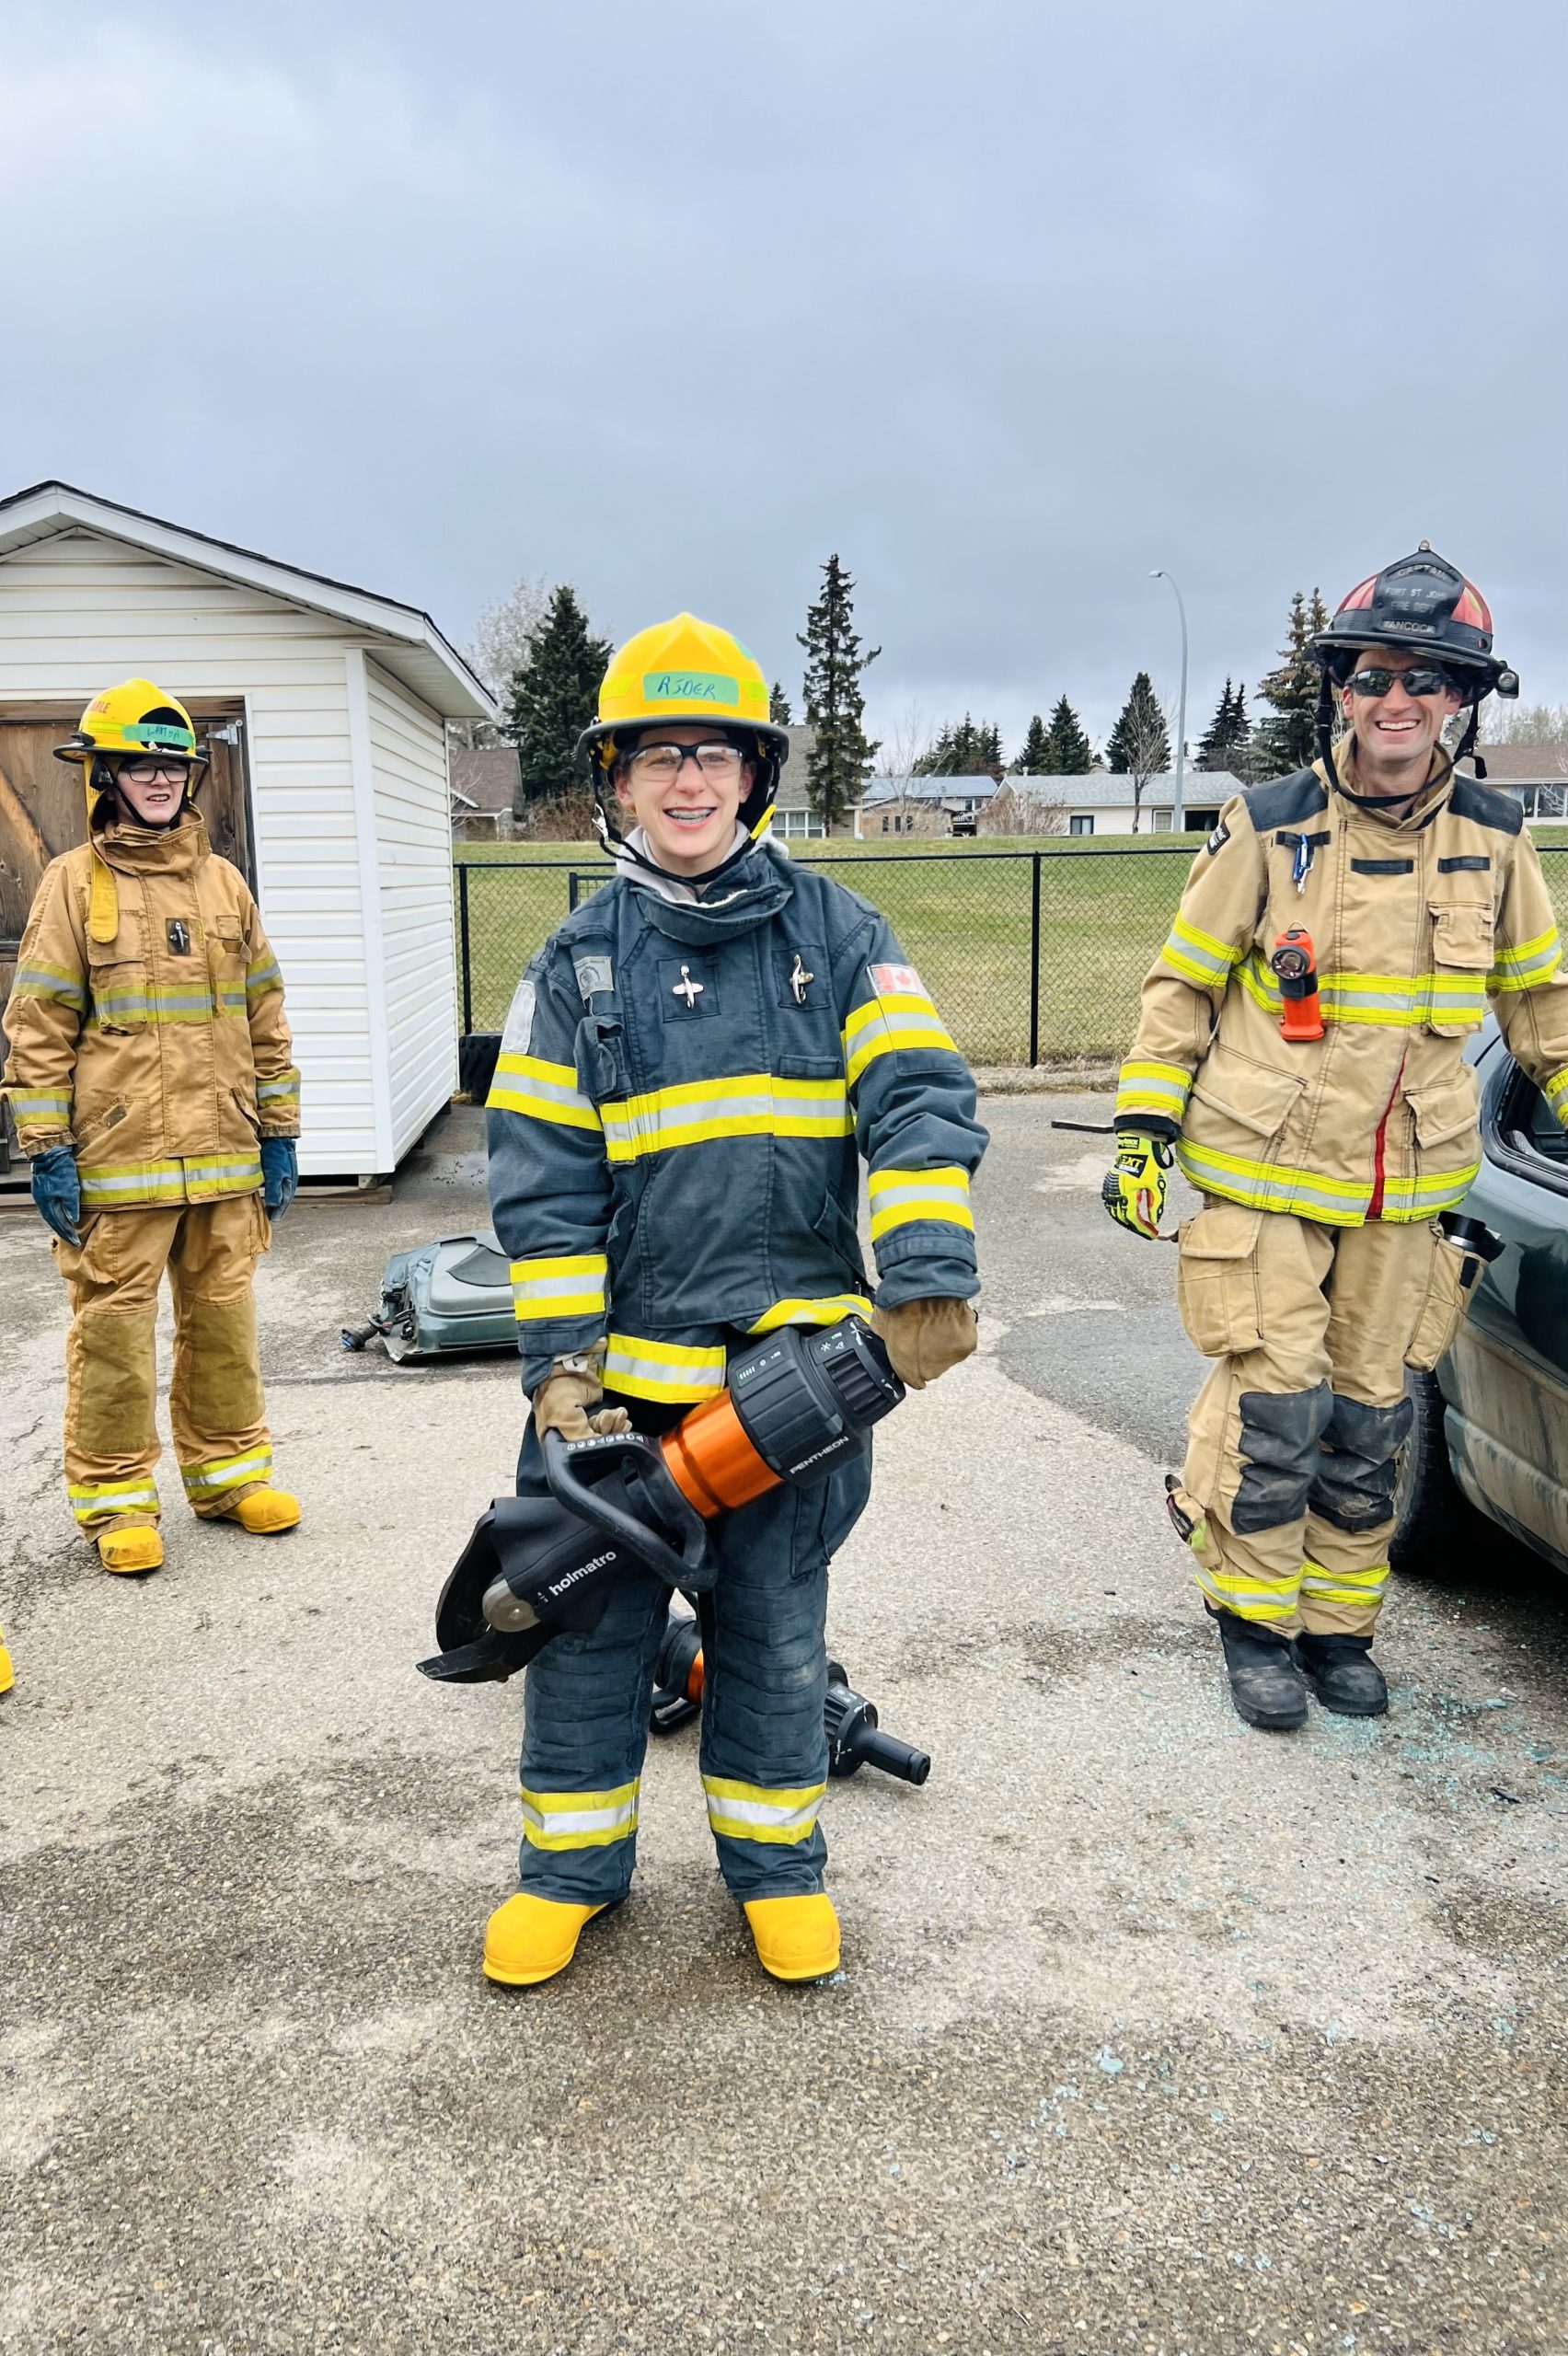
[0,483,497,721]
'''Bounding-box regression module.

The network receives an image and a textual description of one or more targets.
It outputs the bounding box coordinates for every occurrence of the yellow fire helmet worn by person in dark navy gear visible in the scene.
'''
[577,613,789,838]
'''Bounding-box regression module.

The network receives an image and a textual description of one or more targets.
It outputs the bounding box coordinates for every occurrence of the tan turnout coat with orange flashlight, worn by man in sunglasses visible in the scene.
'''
[1116,745,1568,1228]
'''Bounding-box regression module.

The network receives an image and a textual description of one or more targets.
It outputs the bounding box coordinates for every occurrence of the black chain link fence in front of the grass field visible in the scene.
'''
[456,841,1568,1065]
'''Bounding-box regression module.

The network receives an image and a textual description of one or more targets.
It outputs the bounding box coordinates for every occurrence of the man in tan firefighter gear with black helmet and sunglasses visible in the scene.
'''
[1104,544,1568,1727]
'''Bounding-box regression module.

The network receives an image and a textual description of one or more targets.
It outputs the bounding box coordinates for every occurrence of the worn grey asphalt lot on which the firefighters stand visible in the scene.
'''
[0,1095,1568,2356]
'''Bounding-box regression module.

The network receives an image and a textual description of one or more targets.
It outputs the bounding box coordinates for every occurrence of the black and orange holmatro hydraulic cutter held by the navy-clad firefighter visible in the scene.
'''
[419,1317,904,1682]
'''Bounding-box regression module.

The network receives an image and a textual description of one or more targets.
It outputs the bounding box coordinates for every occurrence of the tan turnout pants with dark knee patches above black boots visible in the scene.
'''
[1177,1199,1467,1635]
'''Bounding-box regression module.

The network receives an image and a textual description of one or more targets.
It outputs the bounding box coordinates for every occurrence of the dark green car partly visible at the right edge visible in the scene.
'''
[1389,1022,1568,1572]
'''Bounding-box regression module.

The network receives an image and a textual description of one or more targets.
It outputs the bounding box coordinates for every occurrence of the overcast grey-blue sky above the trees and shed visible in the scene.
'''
[0,0,1568,740]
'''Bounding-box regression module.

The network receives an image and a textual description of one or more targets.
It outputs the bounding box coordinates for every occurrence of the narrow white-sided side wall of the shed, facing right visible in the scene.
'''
[365,662,456,1160]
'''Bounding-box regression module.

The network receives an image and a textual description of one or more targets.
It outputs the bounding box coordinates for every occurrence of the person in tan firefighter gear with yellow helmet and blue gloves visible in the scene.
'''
[5,678,299,1572]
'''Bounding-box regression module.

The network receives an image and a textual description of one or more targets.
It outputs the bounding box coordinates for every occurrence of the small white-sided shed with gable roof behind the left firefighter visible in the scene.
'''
[0,483,494,1175]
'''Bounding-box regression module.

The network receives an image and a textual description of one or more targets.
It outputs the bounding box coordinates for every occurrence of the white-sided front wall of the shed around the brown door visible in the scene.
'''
[0,530,378,1175]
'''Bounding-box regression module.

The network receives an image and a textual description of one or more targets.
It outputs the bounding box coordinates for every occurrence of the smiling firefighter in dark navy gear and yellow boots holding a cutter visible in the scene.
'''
[485,615,986,1986]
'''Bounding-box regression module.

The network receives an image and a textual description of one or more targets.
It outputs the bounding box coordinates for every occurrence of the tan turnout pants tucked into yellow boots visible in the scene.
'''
[54,1195,273,1539]
